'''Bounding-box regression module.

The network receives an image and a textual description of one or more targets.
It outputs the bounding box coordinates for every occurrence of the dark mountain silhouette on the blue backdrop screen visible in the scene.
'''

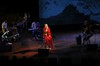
[40,4,89,25]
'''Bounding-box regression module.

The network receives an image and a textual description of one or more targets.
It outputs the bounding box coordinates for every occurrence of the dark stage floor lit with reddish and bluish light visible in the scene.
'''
[0,30,100,64]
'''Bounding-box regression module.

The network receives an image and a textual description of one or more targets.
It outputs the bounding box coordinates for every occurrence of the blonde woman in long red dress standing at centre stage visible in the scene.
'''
[43,24,54,49]
